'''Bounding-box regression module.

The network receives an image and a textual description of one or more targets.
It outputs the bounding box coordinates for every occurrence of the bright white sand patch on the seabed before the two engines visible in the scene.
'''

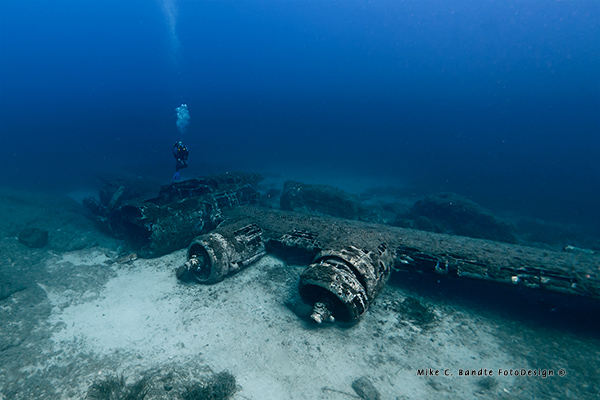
[38,251,515,400]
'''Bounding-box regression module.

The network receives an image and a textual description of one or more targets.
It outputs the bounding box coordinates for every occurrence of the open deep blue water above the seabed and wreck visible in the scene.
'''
[0,0,600,225]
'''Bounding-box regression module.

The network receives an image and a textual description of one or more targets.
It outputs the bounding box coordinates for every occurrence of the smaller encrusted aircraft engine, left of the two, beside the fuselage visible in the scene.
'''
[177,224,265,283]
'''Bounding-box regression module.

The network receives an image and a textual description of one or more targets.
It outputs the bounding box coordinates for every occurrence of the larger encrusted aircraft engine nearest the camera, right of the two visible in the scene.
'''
[299,243,393,323]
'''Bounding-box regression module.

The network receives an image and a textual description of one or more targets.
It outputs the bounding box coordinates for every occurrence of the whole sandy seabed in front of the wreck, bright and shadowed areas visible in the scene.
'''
[0,188,600,400]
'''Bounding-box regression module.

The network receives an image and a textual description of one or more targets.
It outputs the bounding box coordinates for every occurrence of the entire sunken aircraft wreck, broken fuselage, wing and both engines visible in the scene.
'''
[88,174,600,323]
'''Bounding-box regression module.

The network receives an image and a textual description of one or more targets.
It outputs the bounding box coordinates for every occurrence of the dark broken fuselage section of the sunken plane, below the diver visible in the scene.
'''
[84,173,260,258]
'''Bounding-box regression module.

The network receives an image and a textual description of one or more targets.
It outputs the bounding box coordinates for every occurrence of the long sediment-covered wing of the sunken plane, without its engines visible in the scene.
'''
[224,206,600,298]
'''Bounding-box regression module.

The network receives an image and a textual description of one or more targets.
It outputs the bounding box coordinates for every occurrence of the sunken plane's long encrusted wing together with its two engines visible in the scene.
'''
[171,206,600,323]
